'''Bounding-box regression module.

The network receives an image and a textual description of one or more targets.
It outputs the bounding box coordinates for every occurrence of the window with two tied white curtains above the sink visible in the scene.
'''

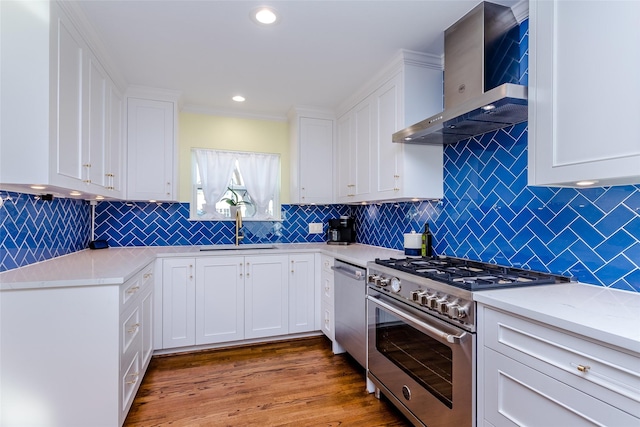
[191,149,280,221]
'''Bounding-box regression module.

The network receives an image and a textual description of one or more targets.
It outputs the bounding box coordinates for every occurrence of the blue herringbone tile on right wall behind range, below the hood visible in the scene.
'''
[355,123,640,292]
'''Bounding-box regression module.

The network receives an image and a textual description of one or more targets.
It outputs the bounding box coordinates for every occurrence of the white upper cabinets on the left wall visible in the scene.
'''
[0,2,123,198]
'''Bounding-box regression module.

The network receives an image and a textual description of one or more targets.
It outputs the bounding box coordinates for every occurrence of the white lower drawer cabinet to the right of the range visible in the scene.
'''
[477,305,640,427]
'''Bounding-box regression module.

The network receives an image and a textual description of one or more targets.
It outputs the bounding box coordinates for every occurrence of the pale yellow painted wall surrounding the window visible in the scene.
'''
[178,113,289,204]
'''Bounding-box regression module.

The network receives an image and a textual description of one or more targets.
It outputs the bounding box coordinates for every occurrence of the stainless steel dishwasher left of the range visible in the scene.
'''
[332,260,367,367]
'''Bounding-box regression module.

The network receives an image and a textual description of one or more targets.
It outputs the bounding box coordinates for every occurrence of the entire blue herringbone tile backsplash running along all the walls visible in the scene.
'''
[0,17,640,292]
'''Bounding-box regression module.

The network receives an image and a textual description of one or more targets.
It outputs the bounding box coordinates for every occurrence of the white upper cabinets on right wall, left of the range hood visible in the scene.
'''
[336,51,443,203]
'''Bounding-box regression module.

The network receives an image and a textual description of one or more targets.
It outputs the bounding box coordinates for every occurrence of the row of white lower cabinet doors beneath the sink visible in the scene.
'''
[157,254,318,349]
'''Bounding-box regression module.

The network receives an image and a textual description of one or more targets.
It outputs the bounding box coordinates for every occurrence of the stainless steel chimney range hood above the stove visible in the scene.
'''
[393,2,528,145]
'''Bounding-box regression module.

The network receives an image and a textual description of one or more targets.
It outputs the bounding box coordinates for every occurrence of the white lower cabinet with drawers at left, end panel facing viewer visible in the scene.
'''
[0,263,153,427]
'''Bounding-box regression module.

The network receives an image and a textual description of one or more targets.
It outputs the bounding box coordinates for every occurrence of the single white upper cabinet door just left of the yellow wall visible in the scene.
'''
[127,98,176,201]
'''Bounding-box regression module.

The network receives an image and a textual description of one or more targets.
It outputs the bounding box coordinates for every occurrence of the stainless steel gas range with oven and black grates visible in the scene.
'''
[367,257,570,427]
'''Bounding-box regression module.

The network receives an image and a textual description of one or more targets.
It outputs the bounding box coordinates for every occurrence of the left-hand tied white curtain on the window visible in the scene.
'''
[196,150,236,219]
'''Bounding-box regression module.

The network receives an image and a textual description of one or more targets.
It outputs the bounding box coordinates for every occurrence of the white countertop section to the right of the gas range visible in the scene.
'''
[474,283,640,354]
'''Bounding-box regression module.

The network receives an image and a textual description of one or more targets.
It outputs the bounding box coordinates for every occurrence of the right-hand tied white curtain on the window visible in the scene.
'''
[237,153,280,220]
